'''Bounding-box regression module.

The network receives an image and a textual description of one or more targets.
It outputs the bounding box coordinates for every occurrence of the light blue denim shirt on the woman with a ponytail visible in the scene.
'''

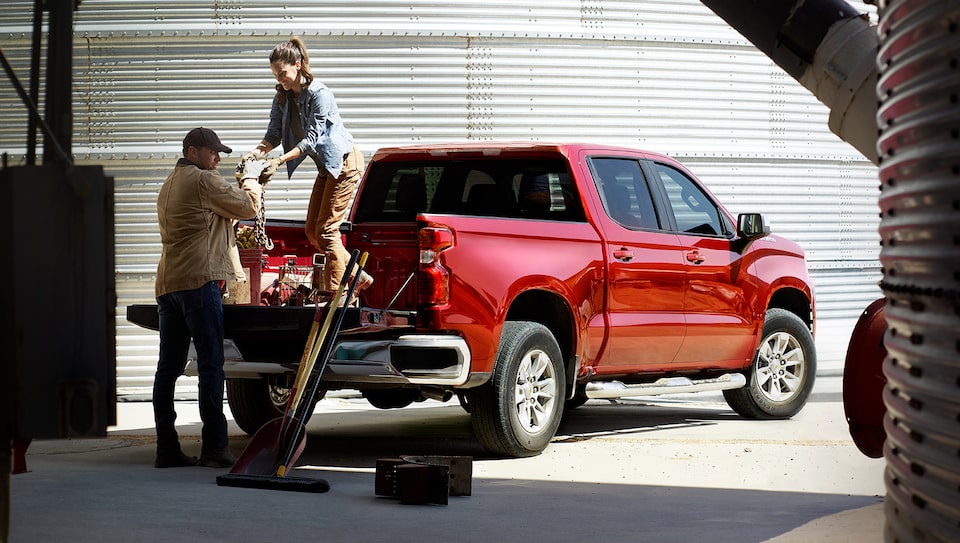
[263,79,353,178]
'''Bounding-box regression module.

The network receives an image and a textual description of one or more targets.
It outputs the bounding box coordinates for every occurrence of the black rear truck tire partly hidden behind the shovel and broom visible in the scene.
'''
[227,377,325,435]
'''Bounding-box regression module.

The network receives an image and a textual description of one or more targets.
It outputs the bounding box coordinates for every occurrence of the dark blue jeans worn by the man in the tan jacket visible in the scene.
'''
[153,281,227,456]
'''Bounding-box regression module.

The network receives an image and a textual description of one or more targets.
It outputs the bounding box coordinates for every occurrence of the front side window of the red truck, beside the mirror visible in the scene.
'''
[654,164,729,236]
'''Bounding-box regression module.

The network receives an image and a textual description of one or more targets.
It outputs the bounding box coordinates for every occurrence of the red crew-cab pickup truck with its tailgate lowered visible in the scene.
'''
[128,142,816,456]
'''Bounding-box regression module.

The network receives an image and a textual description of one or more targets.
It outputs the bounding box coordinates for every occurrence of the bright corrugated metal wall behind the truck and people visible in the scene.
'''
[0,0,880,394]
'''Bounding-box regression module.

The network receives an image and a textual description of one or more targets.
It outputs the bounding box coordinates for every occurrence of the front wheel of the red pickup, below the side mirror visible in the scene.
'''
[723,308,817,419]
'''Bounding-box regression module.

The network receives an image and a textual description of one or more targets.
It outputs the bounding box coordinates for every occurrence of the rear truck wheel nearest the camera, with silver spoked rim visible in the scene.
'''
[468,321,566,457]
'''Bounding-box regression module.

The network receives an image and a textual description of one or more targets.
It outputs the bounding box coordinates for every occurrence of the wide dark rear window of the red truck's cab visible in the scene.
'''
[354,158,586,223]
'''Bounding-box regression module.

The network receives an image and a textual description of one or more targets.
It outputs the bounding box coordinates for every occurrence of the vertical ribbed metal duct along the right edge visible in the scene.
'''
[877,0,960,543]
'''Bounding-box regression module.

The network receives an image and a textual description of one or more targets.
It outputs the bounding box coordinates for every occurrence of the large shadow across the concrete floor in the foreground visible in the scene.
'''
[10,442,880,543]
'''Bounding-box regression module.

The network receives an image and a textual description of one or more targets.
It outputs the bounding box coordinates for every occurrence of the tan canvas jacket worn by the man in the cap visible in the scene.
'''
[154,158,262,297]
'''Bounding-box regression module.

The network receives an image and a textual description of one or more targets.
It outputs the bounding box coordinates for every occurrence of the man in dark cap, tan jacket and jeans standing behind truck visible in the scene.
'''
[153,128,267,468]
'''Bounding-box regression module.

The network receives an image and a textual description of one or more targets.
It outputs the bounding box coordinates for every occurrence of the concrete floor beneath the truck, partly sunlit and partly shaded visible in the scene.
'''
[10,378,885,543]
